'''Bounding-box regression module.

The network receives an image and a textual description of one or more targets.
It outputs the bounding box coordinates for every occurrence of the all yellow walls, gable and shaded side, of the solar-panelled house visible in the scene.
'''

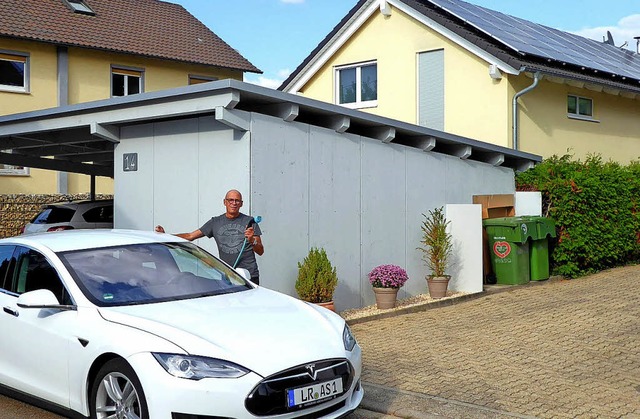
[301,8,640,164]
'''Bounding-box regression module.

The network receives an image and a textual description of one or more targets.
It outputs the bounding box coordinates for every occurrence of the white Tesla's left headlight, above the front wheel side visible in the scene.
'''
[153,353,249,380]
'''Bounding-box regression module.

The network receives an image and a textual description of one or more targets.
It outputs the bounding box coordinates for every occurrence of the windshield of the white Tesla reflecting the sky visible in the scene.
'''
[59,243,252,306]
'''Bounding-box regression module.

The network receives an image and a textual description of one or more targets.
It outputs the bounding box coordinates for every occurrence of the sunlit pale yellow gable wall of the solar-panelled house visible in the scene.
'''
[301,8,510,146]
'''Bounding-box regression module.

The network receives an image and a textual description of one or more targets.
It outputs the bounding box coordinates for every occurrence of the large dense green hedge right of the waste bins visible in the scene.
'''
[516,155,640,278]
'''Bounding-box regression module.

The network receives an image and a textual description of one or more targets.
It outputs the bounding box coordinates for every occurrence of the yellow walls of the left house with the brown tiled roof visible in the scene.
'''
[0,38,243,194]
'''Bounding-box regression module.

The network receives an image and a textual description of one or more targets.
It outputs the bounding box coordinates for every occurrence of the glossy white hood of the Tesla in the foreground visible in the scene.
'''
[100,287,345,376]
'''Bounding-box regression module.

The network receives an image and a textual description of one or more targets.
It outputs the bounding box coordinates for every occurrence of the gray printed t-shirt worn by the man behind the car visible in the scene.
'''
[200,213,262,278]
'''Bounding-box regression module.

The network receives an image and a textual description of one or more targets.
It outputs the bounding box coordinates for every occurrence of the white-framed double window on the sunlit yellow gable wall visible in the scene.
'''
[336,62,378,108]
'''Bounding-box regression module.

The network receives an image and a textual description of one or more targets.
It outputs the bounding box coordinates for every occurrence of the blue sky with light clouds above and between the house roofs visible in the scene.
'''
[166,0,640,88]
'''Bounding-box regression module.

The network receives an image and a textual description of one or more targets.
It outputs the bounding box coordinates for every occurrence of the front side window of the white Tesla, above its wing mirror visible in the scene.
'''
[11,247,71,304]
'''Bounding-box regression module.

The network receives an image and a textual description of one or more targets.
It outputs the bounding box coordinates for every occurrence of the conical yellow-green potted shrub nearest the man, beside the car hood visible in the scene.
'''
[296,247,338,311]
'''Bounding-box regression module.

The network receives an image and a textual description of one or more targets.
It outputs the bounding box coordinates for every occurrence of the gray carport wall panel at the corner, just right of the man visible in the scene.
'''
[251,114,309,296]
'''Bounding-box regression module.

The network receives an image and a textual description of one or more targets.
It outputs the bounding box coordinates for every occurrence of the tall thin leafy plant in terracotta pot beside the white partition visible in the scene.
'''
[418,207,453,298]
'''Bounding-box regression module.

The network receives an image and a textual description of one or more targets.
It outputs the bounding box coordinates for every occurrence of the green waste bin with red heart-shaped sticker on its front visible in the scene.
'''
[482,217,536,285]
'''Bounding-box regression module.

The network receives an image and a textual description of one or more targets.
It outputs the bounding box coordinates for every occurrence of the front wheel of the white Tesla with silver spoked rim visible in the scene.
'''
[89,358,149,419]
